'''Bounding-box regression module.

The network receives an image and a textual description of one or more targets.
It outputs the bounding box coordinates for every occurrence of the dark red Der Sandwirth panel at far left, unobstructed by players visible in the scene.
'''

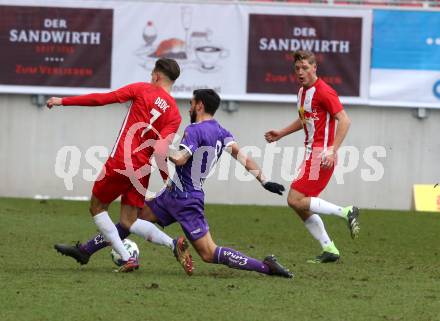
[0,6,113,93]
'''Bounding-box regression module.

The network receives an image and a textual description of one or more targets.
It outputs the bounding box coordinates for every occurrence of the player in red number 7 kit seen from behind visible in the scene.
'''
[47,58,189,272]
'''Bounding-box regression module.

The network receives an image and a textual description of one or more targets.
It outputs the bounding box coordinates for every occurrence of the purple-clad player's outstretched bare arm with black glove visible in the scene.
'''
[226,143,285,195]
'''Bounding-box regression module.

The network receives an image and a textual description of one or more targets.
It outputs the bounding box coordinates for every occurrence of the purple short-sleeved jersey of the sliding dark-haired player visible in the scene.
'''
[173,119,234,192]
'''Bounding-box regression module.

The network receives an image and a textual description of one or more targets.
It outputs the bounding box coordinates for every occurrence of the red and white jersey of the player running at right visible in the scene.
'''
[297,78,343,159]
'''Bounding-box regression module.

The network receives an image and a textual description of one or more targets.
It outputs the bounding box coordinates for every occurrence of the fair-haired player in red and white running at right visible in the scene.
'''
[265,51,359,263]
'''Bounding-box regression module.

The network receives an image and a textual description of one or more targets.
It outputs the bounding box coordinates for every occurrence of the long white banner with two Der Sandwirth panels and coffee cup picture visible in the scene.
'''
[0,0,372,104]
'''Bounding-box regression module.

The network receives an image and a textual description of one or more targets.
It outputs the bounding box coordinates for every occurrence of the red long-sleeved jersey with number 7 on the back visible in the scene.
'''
[62,82,182,170]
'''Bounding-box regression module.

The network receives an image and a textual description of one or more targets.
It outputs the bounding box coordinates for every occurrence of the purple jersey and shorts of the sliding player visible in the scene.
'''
[146,119,234,241]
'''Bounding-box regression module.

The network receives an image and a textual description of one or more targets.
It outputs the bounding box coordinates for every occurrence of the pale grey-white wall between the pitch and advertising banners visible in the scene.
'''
[0,95,440,209]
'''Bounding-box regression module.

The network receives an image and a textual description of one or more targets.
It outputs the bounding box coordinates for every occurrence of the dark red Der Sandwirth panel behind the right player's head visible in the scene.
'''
[246,14,365,98]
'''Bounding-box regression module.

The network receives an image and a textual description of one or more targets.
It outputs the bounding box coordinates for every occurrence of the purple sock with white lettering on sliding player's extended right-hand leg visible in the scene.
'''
[213,246,270,274]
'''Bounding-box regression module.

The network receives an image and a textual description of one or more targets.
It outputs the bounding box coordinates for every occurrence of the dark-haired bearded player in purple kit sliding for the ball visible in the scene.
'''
[56,89,293,278]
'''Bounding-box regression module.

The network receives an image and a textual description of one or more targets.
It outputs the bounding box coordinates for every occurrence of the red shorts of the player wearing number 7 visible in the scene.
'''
[92,159,150,208]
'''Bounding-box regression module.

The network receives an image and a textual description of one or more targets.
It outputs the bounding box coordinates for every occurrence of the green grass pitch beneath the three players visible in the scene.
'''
[0,198,440,321]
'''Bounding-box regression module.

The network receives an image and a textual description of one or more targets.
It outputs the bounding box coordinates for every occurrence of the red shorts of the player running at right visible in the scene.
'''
[290,157,334,197]
